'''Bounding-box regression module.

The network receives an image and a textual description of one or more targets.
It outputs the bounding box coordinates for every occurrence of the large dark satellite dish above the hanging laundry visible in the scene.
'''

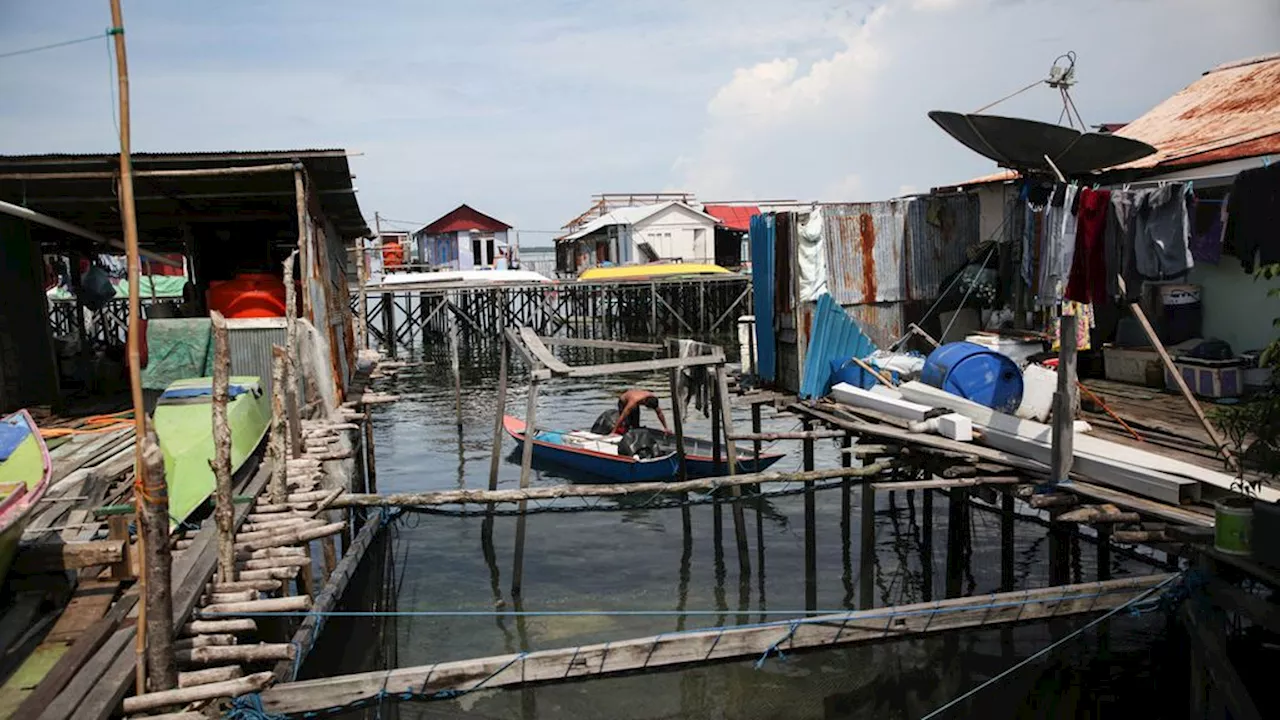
[929,110,1156,176]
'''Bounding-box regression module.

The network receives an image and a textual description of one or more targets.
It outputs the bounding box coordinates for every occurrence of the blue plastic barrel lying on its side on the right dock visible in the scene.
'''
[920,342,1023,414]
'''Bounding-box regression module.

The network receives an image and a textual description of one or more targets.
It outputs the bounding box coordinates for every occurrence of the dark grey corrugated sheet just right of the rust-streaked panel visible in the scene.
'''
[906,195,979,300]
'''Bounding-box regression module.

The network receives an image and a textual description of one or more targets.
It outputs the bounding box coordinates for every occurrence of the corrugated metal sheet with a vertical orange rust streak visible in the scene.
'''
[823,200,910,305]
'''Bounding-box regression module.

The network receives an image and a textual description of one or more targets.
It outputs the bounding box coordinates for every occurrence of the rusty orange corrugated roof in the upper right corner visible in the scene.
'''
[1115,54,1280,169]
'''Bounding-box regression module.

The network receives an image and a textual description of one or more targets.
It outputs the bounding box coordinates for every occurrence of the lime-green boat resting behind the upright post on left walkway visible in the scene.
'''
[155,377,271,527]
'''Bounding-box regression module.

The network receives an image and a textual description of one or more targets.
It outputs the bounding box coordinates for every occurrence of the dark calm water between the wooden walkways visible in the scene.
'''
[303,345,1187,720]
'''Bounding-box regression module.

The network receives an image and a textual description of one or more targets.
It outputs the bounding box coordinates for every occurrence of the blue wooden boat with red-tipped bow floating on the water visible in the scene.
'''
[502,415,782,483]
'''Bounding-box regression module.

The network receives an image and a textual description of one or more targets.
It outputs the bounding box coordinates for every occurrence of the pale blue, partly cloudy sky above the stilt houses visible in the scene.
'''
[0,0,1280,246]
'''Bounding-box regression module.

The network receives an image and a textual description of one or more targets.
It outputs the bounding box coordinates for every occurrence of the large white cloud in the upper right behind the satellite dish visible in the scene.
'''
[677,0,1280,200]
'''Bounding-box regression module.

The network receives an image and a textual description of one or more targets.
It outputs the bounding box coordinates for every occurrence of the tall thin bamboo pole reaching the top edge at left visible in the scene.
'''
[109,0,152,693]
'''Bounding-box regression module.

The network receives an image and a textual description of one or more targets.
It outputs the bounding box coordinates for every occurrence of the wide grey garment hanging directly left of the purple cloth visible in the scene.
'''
[1133,183,1196,281]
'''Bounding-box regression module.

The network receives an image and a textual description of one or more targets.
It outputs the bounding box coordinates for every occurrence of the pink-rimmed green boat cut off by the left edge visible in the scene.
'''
[0,410,52,583]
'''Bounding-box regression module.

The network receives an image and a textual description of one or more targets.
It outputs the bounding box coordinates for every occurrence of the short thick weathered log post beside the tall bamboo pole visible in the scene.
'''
[138,429,178,692]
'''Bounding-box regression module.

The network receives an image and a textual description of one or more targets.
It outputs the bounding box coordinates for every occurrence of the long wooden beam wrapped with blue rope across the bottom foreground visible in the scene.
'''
[261,575,1176,714]
